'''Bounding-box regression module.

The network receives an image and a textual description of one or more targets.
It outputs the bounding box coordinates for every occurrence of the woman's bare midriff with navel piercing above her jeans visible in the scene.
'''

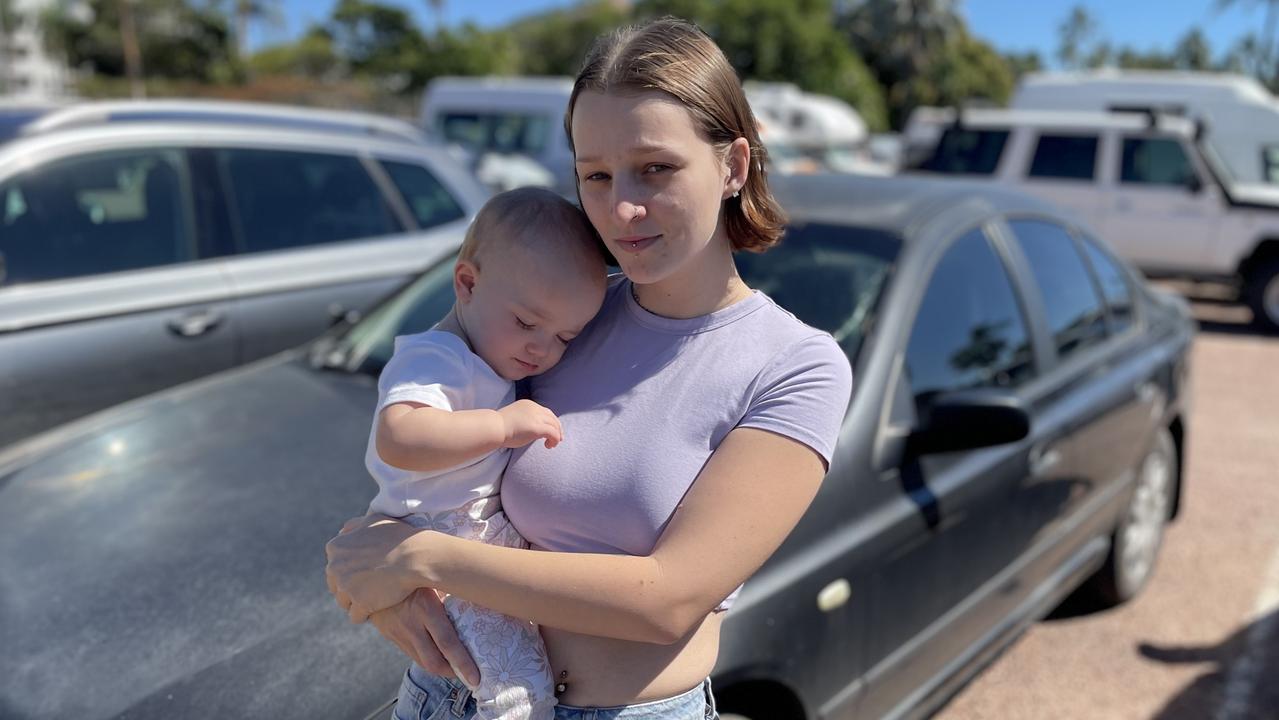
[542,613,724,707]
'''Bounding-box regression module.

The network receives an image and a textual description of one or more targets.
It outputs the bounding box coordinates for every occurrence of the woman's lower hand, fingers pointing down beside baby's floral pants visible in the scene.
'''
[368,587,480,688]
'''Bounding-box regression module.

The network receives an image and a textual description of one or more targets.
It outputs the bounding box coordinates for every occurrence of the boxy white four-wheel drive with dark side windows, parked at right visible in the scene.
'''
[917,110,1279,331]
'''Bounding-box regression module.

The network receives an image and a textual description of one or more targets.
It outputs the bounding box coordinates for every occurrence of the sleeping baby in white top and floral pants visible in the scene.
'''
[365,188,605,720]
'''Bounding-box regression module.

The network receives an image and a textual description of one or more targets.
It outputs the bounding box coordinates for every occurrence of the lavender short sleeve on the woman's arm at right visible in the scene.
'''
[738,333,853,467]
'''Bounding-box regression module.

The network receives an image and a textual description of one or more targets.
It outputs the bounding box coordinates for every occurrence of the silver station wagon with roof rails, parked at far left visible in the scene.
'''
[0,101,487,446]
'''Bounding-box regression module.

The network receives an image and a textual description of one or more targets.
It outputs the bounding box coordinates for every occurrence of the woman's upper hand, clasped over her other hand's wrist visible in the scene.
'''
[325,514,421,623]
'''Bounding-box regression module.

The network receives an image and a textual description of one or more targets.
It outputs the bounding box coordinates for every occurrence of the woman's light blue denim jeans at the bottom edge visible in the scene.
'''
[391,665,719,720]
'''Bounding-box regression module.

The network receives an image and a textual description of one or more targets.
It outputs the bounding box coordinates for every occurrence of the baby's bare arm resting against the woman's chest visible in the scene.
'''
[376,400,564,472]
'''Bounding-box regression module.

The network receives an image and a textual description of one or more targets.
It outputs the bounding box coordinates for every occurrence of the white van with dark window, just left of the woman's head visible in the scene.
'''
[420,77,576,197]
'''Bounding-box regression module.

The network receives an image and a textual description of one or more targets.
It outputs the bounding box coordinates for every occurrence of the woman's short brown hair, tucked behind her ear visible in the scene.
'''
[564,17,785,252]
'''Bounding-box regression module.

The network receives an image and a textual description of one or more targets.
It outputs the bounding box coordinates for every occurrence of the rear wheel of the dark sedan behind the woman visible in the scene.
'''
[1092,427,1177,605]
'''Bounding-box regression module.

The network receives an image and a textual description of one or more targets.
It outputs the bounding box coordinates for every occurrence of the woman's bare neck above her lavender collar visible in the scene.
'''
[632,240,751,318]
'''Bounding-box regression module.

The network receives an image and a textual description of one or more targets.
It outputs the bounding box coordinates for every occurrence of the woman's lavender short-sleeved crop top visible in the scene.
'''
[501,276,852,609]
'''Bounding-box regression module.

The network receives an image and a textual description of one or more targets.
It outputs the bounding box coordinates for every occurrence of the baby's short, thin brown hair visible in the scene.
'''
[458,187,604,267]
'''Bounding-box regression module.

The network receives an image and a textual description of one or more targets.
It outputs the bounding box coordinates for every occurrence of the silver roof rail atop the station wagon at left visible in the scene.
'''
[23,100,423,142]
